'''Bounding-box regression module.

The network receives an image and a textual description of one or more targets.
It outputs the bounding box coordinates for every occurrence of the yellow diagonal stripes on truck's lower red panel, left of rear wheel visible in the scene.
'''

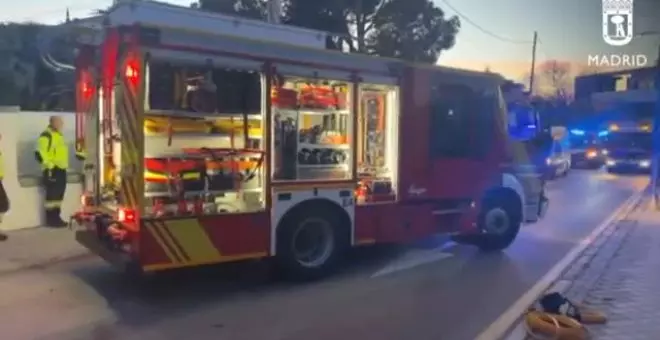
[143,218,267,271]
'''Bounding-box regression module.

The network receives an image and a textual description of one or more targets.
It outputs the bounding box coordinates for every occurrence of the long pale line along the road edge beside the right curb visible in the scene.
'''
[475,186,645,340]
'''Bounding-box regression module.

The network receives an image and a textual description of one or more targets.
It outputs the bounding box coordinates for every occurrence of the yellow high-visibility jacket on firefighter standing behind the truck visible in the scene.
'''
[35,127,69,170]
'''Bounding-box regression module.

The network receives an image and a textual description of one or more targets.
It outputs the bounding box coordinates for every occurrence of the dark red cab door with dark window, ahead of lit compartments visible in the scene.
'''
[428,82,499,215]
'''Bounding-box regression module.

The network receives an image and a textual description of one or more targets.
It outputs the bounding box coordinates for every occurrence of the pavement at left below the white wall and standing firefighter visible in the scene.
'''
[0,228,88,275]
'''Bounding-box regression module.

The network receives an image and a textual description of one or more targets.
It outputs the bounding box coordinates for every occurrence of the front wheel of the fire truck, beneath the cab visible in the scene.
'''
[474,191,522,252]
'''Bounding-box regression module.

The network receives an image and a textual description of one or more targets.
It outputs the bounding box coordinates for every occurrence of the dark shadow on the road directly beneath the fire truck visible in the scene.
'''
[65,246,405,339]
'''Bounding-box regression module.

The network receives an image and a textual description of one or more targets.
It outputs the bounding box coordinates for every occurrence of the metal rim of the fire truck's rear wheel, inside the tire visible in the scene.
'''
[291,218,335,268]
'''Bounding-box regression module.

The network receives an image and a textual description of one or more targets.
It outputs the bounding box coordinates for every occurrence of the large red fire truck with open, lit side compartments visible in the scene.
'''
[53,1,548,279]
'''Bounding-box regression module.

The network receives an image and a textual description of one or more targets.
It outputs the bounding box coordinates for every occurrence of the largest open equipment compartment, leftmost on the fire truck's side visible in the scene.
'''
[144,53,265,217]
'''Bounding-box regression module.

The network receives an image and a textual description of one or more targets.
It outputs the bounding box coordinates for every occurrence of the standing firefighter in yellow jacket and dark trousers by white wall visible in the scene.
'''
[35,116,85,228]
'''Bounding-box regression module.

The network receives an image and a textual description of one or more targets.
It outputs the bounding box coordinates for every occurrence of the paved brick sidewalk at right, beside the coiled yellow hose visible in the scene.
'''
[536,198,660,340]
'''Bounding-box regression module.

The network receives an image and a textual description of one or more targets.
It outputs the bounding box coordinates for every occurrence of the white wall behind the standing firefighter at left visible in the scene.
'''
[0,107,82,230]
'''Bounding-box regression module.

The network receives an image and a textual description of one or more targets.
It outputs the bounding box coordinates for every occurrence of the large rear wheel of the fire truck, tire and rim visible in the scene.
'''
[275,202,350,281]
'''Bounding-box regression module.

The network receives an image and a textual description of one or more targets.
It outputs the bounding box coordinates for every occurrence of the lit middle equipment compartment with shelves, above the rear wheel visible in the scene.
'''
[272,79,352,180]
